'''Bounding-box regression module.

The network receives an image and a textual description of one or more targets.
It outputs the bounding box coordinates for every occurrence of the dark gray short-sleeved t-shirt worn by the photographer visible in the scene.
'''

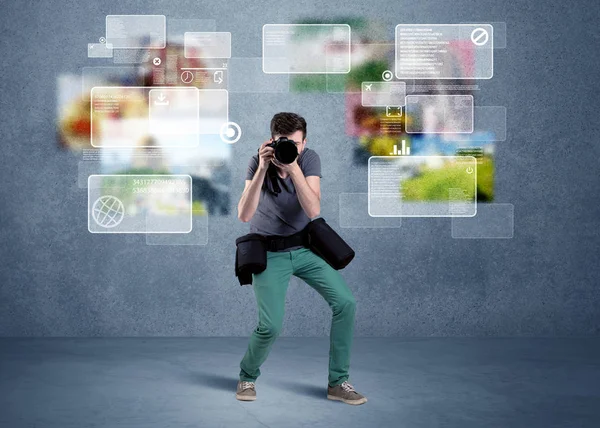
[246,147,321,236]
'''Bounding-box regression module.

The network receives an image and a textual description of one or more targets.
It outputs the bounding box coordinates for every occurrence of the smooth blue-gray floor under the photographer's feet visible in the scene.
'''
[0,337,600,428]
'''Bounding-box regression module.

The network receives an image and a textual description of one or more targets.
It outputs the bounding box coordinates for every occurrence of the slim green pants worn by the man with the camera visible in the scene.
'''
[240,248,356,386]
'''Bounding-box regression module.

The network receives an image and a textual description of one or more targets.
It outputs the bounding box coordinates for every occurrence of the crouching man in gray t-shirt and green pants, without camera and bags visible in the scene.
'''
[236,113,367,404]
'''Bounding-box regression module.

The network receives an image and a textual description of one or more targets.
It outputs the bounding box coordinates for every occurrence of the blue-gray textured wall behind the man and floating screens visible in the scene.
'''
[0,0,600,336]
